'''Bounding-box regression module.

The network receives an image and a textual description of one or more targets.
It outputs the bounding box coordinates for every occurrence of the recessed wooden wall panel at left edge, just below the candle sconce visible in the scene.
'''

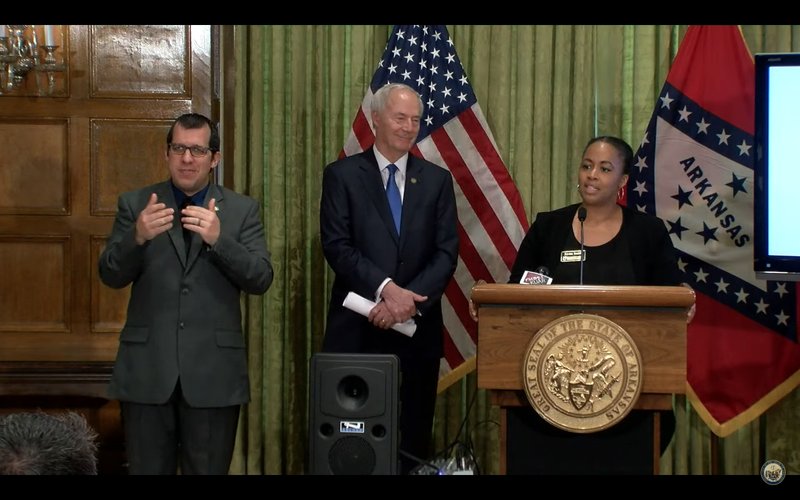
[0,118,69,215]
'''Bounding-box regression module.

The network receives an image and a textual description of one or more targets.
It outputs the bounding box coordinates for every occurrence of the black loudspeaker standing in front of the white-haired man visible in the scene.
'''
[309,353,400,475]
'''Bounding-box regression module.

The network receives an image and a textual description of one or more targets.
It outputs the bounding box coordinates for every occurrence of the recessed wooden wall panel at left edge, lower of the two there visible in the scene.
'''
[0,236,70,335]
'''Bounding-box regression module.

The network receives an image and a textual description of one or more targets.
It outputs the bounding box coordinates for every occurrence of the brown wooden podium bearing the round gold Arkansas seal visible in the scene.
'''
[472,284,694,474]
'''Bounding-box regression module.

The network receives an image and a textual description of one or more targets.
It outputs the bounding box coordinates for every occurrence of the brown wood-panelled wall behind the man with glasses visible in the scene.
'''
[0,25,219,473]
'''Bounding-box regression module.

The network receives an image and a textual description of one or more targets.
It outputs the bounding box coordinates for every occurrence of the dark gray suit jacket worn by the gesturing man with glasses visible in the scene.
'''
[99,181,273,407]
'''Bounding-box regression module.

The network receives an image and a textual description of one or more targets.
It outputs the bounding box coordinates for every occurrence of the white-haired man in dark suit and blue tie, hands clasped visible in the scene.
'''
[320,84,458,473]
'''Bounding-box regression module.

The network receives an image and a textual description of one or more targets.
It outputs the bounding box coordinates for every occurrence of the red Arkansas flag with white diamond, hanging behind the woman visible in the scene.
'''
[627,26,800,437]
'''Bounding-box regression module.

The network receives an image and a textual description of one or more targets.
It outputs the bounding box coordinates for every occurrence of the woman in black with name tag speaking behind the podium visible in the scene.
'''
[509,136,683,285]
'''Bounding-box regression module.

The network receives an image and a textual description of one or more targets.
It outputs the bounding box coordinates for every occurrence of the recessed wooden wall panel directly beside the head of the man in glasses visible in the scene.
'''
[90,119,172,216]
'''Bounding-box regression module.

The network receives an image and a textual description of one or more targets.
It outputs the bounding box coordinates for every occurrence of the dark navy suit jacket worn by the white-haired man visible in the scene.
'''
[320,148,458,358]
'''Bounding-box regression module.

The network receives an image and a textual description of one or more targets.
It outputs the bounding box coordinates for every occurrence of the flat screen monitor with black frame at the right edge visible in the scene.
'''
[753,53,800,281]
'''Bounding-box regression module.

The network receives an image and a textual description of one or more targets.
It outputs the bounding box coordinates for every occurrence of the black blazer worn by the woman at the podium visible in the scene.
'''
[508,203,683,286]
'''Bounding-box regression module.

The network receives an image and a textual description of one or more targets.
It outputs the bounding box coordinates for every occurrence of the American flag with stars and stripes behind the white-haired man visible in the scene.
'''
[342,25,528,391]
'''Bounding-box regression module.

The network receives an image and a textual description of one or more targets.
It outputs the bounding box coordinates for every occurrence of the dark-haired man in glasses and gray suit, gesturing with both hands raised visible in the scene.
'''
[99,113,272,474]
